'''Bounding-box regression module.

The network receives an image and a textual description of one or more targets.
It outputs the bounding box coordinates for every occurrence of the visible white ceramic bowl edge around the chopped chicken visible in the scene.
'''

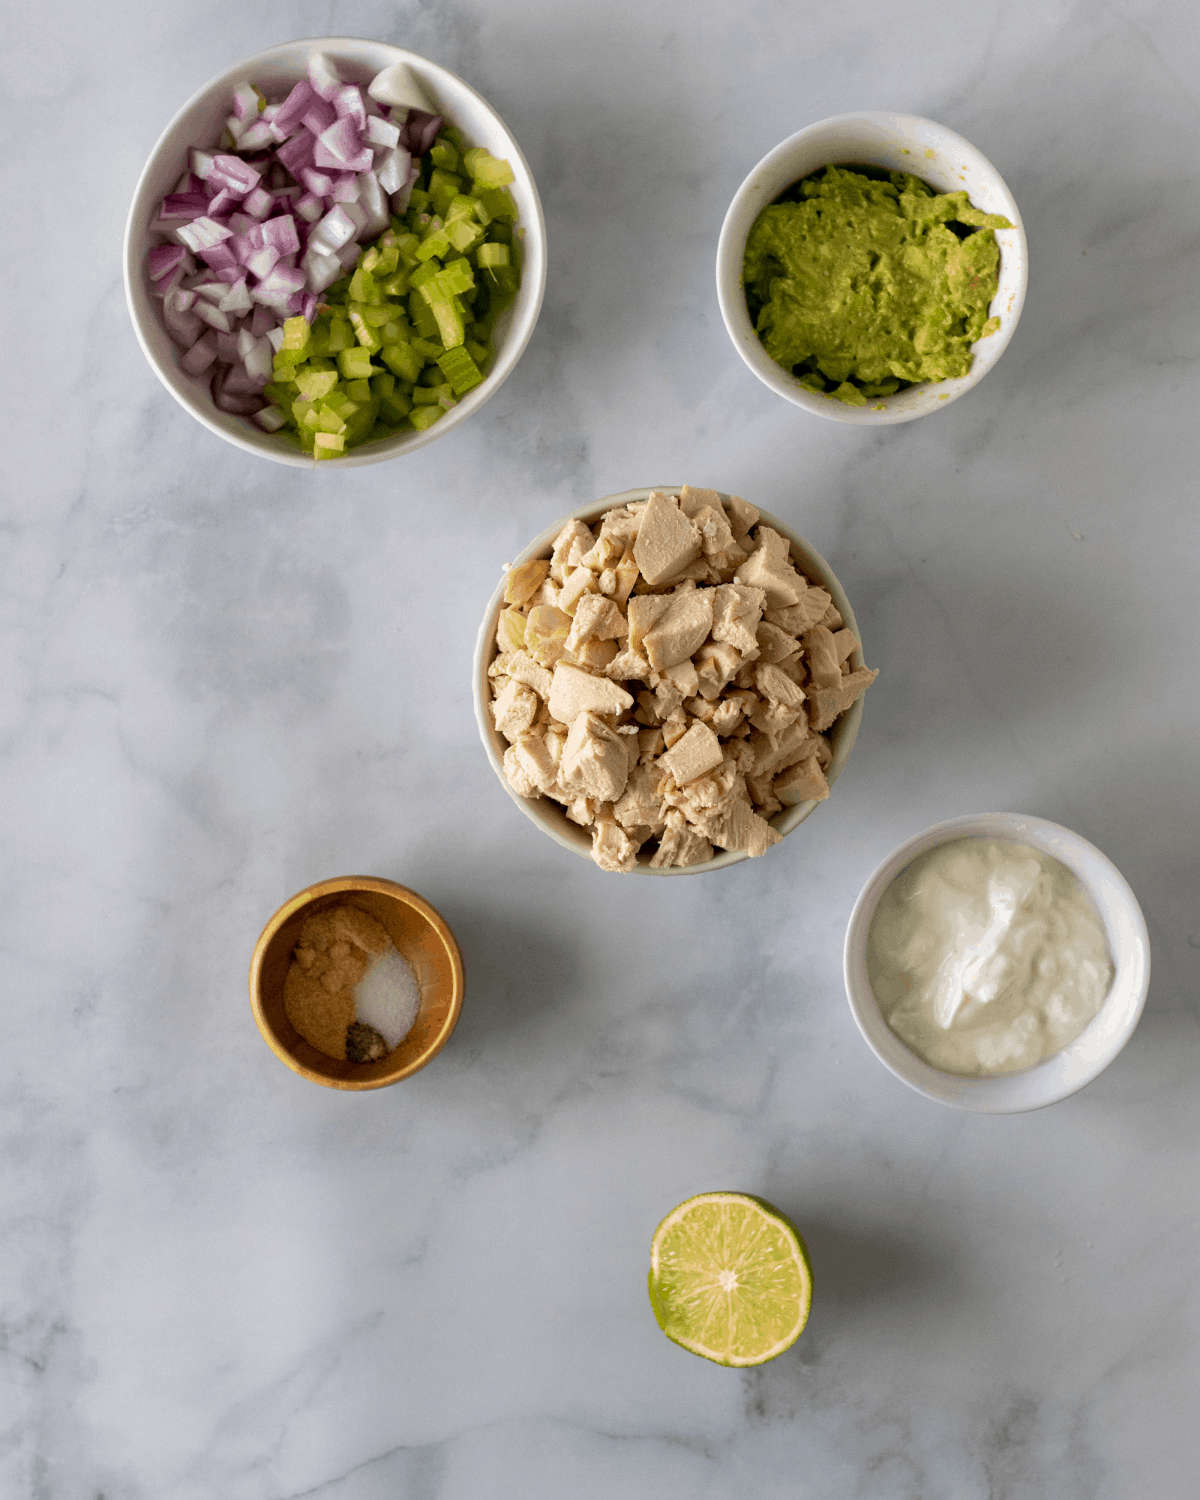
[474,485,866,875]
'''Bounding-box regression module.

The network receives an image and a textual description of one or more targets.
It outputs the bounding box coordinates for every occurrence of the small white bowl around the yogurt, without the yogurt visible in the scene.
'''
[845,813,1151,1115]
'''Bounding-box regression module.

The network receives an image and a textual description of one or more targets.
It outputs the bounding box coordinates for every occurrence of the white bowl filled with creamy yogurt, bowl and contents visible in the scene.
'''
[845,813,1151,1115]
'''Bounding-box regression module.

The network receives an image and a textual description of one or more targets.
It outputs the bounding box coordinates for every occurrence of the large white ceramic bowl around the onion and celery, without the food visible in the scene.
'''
[125,36,546,468]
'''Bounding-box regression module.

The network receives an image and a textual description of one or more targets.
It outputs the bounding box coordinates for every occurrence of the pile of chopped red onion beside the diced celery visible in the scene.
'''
[147,54,465,432]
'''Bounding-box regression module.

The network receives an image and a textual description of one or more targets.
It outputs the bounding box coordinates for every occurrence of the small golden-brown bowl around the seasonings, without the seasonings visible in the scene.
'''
[251,875,464,1089]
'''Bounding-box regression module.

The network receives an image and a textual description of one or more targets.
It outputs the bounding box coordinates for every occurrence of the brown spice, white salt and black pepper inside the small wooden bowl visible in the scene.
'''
[284,902,420,1062]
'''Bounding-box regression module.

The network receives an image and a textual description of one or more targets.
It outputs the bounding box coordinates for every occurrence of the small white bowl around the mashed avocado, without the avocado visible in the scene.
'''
[717,111,1028,428]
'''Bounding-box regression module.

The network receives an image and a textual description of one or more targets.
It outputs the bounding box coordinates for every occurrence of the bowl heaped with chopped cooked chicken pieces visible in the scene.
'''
[474,485,876,875]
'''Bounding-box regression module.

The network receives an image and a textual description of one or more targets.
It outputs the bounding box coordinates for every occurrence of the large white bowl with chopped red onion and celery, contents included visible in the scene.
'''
[125,38,546,465]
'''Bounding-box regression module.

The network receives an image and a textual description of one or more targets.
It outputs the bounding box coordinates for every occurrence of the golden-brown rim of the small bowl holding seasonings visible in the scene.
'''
[249,875,465,1094]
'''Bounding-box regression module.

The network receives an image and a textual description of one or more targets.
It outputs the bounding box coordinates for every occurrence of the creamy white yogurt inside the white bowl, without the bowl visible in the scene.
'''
[867,839,1113,1076]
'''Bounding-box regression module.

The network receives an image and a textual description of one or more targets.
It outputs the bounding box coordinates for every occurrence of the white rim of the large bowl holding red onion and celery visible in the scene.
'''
[122,36,546,470]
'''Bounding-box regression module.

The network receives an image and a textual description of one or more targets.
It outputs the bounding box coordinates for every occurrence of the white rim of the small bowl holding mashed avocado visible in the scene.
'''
[717,110,1029,426]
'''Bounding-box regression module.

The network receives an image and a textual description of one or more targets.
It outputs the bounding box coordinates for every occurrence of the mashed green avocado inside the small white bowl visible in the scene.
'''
[743,167,1013,407]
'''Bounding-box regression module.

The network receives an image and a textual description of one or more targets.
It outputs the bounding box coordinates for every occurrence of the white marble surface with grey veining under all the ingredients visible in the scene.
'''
[0,0,1200,1500]
